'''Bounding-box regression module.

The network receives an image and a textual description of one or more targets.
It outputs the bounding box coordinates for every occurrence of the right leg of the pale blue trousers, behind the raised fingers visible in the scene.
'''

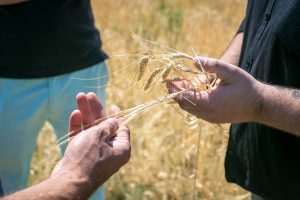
[49,63,108,200]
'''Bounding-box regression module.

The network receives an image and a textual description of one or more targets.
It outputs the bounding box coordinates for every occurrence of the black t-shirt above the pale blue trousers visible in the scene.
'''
[0,0,107,78]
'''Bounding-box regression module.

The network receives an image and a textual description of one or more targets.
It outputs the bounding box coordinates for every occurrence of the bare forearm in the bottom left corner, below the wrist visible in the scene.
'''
[1,173,94,200]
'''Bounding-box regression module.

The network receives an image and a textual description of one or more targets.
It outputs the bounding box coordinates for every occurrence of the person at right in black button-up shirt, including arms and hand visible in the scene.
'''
[168,0,300,199]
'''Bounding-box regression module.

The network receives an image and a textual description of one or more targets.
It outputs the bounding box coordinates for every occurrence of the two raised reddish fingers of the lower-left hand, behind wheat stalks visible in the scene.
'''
[76,93,105,126]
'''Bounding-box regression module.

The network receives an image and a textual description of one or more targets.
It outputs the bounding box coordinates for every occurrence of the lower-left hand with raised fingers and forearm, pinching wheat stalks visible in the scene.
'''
[4,93,130,200]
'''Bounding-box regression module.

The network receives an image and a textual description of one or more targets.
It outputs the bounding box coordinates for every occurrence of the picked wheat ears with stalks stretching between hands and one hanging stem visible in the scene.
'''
[57,42,217,199]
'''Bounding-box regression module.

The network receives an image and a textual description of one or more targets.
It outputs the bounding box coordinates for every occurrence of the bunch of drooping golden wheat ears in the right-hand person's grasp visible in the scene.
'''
[137,52,216,91]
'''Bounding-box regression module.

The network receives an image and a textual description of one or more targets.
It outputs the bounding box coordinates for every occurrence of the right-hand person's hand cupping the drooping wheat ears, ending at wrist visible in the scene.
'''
[167,57,263,123]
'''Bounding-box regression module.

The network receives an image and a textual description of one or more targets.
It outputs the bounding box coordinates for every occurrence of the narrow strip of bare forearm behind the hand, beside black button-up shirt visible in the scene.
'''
[220,33,244,66]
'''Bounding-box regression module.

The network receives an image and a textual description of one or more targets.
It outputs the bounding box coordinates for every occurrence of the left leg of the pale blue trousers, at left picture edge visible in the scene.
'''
[0,78,48,194]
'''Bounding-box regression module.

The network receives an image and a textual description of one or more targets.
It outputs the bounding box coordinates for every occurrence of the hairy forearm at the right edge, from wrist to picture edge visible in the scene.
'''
[256,83,300,137]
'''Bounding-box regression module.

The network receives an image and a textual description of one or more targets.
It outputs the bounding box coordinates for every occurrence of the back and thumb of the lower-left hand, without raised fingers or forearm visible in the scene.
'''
[57,119,130,189]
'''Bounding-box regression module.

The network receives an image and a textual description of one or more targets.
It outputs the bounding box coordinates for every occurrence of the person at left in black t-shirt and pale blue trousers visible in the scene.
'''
[0,0,108,199]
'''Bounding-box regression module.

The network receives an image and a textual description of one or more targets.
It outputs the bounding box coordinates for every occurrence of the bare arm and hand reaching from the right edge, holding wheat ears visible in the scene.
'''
[168,57,300,137]
